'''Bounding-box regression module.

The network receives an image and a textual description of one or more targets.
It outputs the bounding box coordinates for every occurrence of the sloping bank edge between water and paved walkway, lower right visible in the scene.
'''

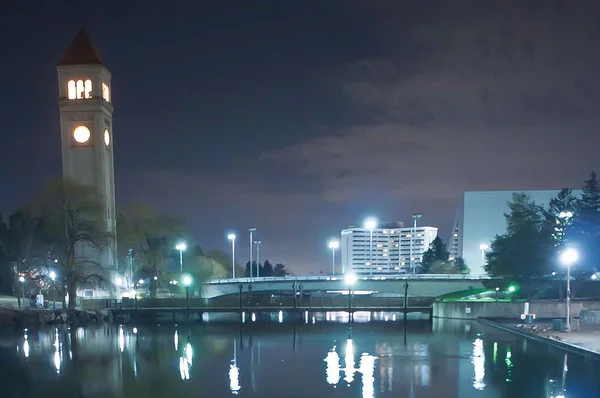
[477,318,600,362]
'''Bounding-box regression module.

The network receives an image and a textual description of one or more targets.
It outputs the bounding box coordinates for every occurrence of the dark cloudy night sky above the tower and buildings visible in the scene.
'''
[0,0,600,273]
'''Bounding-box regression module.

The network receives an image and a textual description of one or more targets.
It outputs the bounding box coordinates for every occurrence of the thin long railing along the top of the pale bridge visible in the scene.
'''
[205,274,494,285]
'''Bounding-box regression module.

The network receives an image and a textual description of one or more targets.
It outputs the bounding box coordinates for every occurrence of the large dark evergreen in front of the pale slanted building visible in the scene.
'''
[485,193,553,278]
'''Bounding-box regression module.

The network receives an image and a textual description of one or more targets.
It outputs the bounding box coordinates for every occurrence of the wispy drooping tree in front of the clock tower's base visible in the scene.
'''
[31,178,114,310]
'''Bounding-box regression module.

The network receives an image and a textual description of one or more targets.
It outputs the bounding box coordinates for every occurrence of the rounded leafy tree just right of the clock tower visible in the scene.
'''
[117,202,187,298]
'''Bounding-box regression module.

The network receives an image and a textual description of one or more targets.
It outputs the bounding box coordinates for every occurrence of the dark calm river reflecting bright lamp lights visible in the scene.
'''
[0,313,600,398]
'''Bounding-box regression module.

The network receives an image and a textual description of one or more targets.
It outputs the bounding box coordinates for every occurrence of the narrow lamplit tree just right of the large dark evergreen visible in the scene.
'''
[544,188,577,247]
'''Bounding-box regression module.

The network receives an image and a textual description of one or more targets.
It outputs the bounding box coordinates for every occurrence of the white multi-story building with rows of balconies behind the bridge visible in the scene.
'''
[341,222,438,275]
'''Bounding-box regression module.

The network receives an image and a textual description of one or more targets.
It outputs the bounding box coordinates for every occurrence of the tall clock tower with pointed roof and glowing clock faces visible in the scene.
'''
[57,29,117,271]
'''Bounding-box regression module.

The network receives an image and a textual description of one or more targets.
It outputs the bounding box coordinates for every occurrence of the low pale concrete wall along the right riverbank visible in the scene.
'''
[432,300,600,320]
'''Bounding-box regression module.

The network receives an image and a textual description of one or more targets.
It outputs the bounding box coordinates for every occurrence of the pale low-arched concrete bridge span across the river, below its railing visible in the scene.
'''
[202,274,491,298]
